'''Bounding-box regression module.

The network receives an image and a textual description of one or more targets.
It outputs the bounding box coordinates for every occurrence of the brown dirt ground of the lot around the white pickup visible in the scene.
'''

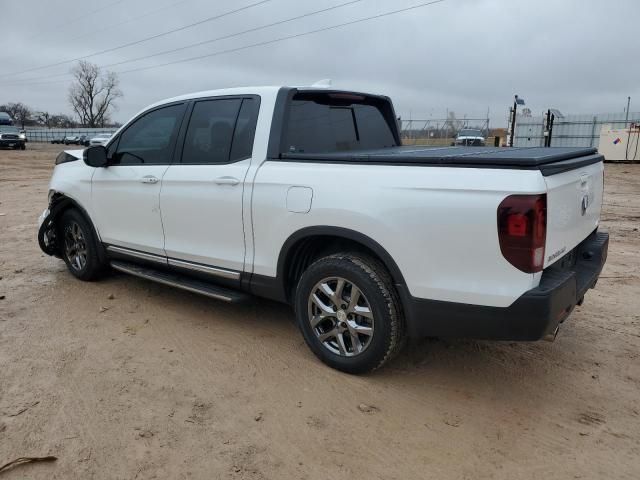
[0,144,640,480]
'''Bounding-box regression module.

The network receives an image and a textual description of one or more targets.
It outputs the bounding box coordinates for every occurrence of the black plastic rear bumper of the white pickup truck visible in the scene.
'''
[400,231,609,341]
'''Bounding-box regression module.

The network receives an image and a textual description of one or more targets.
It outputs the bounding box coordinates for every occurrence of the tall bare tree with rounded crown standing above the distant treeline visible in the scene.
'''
[69,60,122,128]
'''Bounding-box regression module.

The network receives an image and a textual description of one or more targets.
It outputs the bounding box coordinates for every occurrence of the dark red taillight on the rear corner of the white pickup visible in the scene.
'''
[498,193,547,273]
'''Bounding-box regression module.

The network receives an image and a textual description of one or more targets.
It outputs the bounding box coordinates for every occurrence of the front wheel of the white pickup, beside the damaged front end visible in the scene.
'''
[57,208,106,282]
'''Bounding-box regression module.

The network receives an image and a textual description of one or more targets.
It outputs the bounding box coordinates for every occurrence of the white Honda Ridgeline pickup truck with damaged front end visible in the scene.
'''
[38,87,609,373]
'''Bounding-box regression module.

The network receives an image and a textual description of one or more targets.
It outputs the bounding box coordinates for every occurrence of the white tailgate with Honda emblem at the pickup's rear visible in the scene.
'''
[544,162,604,268]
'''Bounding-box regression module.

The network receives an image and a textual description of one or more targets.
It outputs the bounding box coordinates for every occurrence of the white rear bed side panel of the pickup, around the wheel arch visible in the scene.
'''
[252,161,546,307]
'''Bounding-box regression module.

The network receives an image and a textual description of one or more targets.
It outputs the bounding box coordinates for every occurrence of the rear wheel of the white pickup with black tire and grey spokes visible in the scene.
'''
[295,253,406,374]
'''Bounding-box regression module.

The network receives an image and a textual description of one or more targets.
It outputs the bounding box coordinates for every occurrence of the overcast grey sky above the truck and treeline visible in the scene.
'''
[0,0,640,126]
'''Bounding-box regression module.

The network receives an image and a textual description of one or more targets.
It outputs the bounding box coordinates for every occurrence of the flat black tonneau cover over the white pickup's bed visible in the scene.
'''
[274,146,604,176]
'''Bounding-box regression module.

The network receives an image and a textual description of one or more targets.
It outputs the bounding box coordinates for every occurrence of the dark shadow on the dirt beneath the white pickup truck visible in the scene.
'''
[101,274,577,398]
